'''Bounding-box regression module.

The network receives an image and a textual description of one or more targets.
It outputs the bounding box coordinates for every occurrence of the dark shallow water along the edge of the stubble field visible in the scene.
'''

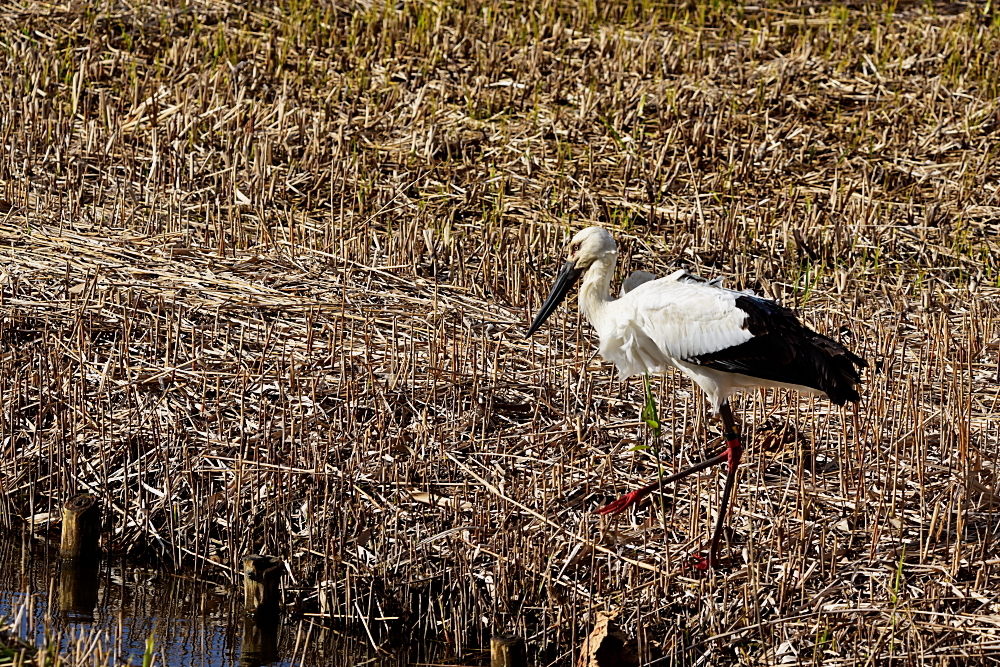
[0,535,424,667]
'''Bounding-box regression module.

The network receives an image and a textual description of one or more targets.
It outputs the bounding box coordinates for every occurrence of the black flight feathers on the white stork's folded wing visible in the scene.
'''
[689,294,868,405]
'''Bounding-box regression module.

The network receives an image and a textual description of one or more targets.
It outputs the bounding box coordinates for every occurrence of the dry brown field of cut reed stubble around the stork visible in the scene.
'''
[0,0,1000,665]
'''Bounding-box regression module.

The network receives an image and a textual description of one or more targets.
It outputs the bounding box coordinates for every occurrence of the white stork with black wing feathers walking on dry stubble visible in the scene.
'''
[527,227,868,569]
